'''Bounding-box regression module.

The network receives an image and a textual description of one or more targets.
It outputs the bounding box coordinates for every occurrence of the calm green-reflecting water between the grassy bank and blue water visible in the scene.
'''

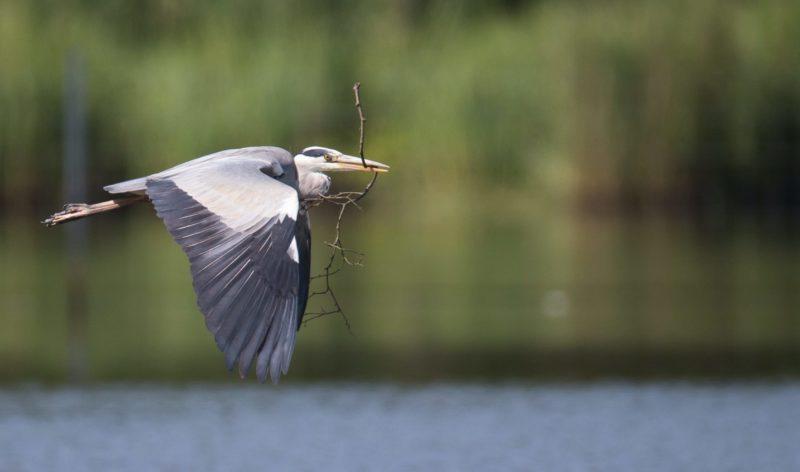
[0,206,800,382]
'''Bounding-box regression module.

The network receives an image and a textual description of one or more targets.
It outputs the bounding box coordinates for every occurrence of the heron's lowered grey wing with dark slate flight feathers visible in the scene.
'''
[147,159,305,382]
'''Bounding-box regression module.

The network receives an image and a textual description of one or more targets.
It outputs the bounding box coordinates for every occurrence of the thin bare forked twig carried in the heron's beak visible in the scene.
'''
[303,82,378,334]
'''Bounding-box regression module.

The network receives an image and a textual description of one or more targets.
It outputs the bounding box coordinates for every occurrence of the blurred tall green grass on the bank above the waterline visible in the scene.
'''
[0,0,800,219]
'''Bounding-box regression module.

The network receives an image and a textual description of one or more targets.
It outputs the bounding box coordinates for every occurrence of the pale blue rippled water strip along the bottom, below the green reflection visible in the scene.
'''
[0,382,800,471]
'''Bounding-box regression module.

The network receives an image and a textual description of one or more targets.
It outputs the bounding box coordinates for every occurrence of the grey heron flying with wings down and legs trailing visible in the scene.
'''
[43,146,389,383]
